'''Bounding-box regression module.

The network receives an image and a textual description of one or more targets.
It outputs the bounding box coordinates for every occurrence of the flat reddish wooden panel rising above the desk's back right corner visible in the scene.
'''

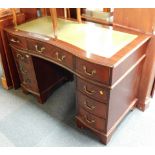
[113,8,155,33]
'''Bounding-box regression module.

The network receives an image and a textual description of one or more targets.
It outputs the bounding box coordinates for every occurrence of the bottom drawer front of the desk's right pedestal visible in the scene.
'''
[78,107,105,131]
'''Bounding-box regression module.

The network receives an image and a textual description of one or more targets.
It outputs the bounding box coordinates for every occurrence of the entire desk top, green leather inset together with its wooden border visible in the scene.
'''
[4,8,151,67]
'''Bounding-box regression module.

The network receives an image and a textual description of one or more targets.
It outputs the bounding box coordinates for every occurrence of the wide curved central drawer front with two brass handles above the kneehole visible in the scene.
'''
[28,40,73,69]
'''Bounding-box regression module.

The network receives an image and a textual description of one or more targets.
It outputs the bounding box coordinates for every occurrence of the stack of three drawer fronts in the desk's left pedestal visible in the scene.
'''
[13,52,38,92]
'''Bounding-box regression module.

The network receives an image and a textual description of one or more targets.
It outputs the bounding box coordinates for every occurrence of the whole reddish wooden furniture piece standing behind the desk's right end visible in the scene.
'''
[113,8,155,111]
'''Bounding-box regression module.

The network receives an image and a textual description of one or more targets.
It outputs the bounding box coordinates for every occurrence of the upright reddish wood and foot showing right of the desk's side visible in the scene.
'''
[137,36,155,111]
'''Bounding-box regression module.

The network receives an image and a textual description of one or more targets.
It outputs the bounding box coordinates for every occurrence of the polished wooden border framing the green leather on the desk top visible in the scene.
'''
[6,23,151,66]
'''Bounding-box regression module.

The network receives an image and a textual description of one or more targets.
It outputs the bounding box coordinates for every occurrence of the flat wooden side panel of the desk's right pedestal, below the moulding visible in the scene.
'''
[107,61,144,131]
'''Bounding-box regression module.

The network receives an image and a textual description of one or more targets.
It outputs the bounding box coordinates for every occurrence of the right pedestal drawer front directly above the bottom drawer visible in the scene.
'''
[77,92,107,118]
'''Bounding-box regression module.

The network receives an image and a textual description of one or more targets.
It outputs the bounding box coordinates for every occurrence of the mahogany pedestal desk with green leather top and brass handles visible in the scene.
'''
[5,17,150,144]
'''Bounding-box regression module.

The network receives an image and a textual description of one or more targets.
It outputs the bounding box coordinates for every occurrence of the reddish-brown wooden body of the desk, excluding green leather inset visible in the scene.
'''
[5,19,151,144]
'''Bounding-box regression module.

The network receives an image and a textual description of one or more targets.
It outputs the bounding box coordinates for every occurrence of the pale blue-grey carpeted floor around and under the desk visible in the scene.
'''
[0,65,155,147]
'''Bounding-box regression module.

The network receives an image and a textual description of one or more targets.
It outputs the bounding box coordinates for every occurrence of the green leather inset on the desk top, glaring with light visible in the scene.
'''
[16,16,137,58]
